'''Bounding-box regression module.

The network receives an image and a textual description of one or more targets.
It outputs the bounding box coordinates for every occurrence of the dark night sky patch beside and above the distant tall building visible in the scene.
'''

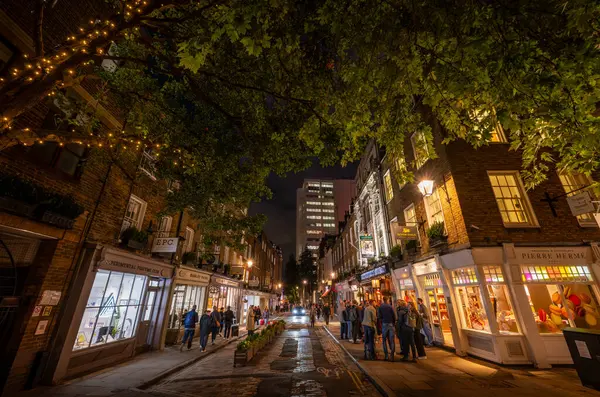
[250,161,358,263]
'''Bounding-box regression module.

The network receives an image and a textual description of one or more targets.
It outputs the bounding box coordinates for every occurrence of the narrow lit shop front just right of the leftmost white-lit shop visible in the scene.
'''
[165,267,211,345]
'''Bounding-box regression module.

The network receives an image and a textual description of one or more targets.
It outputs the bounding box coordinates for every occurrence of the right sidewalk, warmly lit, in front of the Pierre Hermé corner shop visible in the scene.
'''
[320,321,600,397]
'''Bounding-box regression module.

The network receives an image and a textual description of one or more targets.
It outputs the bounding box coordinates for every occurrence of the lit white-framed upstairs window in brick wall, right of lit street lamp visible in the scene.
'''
[488,171,537,227]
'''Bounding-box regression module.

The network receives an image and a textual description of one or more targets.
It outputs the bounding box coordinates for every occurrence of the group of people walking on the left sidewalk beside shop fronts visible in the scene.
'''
[179,305,235,351]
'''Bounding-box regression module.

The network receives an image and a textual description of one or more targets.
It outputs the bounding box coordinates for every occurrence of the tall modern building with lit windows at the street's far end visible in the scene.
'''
[296,179,354,259]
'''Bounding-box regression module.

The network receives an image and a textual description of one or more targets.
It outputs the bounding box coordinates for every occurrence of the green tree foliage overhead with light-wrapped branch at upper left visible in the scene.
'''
[0,0,600,240]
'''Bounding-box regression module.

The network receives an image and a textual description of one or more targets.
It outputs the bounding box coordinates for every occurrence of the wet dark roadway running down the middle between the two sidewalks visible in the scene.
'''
[146,316,379,397]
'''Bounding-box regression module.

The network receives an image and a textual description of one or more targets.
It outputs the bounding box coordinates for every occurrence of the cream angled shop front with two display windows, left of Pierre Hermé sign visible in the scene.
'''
[440,248,532,364]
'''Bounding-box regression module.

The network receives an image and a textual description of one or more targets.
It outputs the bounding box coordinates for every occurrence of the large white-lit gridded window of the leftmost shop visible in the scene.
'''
[73,270,147,350]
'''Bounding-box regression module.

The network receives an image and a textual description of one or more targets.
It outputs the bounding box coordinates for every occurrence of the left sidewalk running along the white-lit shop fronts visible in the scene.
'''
[18,317,279,397]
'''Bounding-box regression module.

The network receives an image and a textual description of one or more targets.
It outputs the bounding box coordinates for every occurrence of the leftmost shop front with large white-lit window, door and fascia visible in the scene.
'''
[57,247,174,378]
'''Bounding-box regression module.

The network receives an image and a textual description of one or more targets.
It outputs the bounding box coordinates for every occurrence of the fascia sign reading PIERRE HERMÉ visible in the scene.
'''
[515,247,591,265]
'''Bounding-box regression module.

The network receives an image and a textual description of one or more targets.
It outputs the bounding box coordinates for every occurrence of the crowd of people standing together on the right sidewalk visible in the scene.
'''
[340,297,433,361]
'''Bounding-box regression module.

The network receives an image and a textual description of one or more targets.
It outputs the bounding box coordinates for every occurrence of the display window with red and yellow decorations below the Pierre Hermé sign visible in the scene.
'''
[525,283,600,334]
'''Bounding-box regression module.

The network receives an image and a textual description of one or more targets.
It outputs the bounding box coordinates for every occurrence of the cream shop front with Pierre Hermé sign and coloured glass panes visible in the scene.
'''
[504,244,600,366]
